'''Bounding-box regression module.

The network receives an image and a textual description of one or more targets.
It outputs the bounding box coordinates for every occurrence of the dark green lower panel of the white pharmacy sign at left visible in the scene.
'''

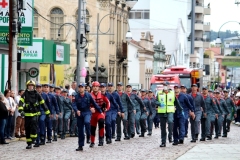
[0,27,33,46]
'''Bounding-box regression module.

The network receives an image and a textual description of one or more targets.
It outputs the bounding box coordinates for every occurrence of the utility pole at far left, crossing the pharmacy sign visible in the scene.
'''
[12,0,19,93]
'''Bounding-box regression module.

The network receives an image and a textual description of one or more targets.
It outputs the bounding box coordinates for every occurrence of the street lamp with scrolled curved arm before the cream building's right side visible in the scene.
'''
[96,13,132,81]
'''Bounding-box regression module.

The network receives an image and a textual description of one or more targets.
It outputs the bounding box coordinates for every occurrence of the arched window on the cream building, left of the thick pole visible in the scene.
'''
[50,8,64,40]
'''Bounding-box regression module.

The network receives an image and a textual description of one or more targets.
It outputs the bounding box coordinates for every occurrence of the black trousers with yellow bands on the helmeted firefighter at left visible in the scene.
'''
[25,116,38,144]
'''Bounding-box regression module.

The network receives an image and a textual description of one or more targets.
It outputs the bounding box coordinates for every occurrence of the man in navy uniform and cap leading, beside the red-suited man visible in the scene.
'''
[72,83,103,151]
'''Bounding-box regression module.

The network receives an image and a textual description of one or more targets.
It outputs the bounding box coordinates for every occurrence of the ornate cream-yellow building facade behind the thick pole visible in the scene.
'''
[33,0,136,84]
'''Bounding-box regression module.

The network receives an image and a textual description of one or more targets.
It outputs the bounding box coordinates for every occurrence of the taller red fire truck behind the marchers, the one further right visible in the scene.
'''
[162,66,203,91]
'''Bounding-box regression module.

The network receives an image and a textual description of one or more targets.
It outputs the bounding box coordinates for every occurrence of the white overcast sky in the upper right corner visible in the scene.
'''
[204,0,240,32]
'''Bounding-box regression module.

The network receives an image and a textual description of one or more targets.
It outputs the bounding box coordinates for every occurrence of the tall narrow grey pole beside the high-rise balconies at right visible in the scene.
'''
[191,0,196,54]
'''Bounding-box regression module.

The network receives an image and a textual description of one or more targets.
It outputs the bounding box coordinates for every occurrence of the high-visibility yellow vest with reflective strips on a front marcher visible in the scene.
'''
[158,91,175,113]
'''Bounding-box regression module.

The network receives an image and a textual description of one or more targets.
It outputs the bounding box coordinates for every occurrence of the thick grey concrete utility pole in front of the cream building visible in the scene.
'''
[77,0,86,84]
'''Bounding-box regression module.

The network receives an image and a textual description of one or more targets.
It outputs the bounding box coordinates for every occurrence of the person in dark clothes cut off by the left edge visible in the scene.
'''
[0,92,8,144]
